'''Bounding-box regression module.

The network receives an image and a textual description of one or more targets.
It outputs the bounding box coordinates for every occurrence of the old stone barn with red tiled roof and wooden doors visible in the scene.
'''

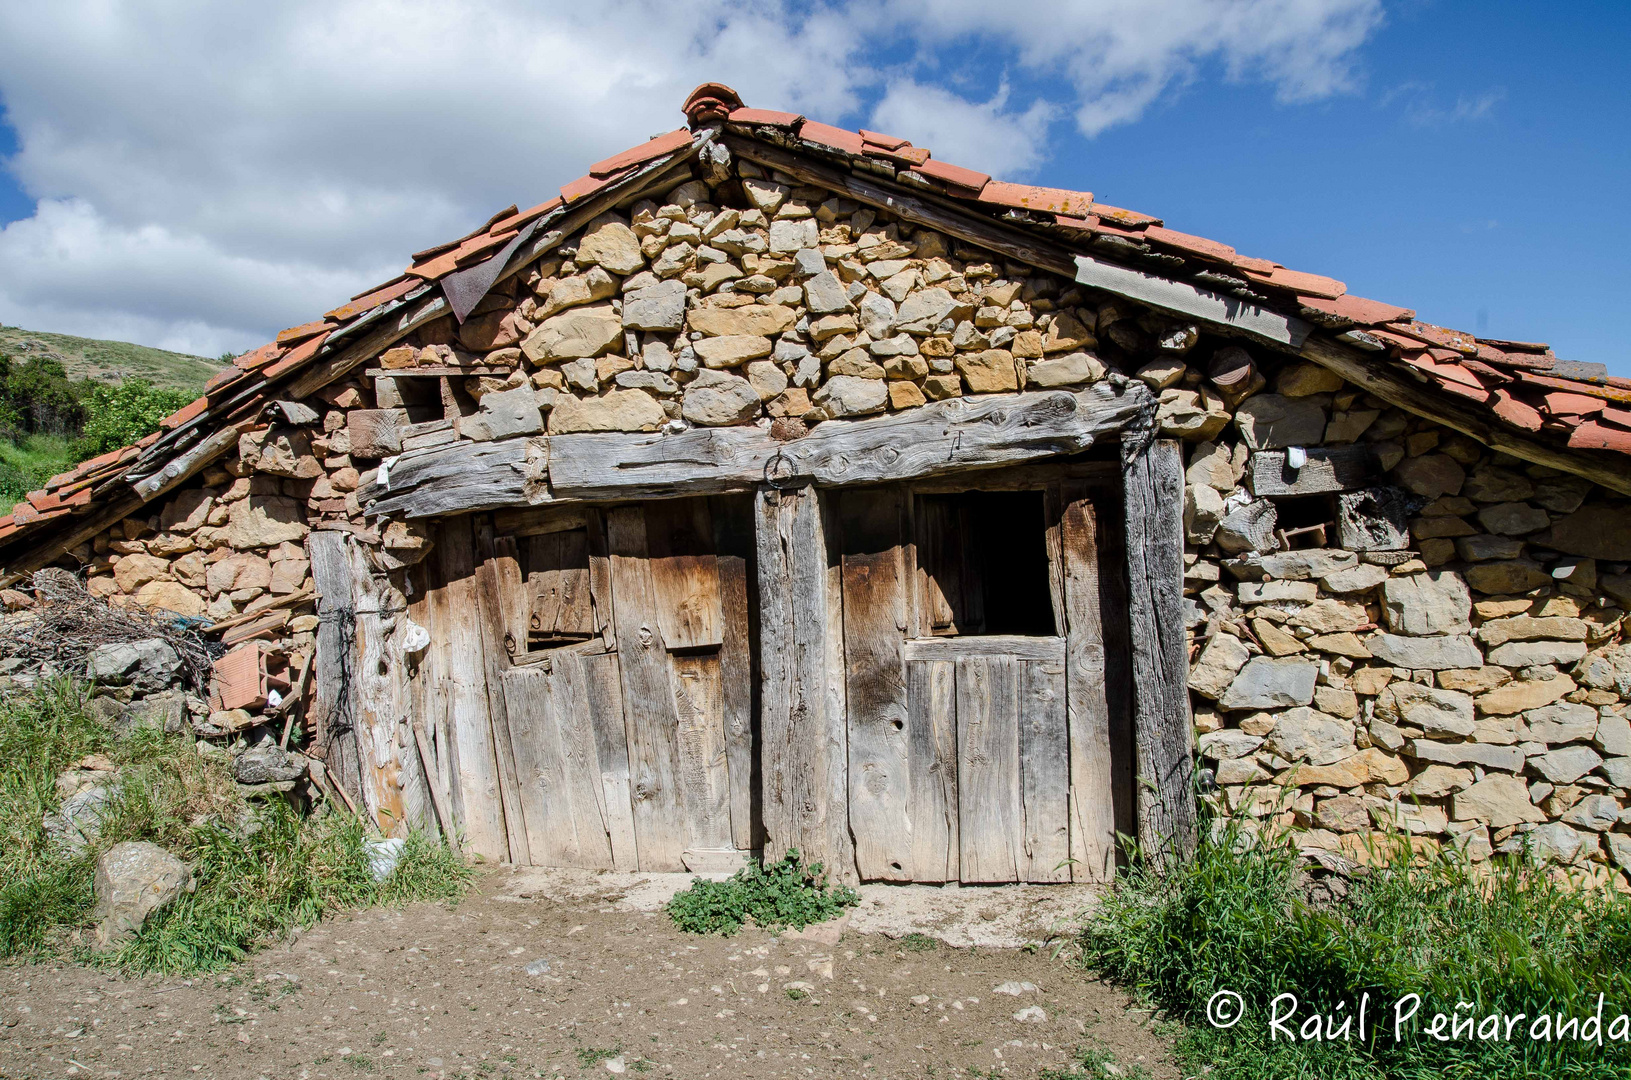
[0,85,1631,886]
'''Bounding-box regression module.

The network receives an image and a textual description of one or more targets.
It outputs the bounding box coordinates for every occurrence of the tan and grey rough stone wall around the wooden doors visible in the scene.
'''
[50,148,1631,884]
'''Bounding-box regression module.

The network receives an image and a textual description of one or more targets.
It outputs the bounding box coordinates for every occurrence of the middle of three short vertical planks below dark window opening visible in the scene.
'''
[957,656,1023,883]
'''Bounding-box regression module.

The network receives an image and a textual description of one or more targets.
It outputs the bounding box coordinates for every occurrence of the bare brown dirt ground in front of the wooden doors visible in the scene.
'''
[0,870,1178,1080]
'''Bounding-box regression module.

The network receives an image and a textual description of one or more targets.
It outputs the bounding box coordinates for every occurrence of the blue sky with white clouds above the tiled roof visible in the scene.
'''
[0,0,1631,375]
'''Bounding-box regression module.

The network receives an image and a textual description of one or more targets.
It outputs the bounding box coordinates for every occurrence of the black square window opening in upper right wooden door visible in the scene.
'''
[917,491,1059,636]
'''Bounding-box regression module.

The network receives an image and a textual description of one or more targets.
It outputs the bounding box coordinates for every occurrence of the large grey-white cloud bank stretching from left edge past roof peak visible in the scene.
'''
[0,0,1378,354]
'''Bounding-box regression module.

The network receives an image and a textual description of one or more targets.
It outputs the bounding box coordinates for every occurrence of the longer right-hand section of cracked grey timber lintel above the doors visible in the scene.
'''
[548,389,1148,506]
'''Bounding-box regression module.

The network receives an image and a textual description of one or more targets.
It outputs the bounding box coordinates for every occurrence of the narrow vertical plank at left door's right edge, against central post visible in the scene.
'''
[711,496,763,850]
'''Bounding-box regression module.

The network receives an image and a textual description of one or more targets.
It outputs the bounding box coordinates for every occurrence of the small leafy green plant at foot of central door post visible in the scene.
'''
[667,850,861,936]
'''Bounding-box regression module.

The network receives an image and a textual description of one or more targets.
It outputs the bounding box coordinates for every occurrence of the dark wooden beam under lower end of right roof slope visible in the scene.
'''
[1302,336,1631,494]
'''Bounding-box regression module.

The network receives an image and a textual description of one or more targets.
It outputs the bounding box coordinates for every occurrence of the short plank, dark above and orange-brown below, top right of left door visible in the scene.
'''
[646,499,724,649]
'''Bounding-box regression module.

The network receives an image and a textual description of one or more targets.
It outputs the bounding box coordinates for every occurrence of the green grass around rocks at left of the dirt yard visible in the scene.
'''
[0,682,470,972]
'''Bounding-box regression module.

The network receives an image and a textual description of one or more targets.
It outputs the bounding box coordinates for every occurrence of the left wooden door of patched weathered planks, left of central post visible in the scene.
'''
[424,498,762,871]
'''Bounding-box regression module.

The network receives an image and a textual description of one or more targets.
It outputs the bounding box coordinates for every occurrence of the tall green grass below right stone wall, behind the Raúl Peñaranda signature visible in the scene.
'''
[1081,822,1631,1080]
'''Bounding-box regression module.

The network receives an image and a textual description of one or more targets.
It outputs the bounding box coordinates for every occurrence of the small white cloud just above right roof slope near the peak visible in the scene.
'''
[873,78,1059,176]
